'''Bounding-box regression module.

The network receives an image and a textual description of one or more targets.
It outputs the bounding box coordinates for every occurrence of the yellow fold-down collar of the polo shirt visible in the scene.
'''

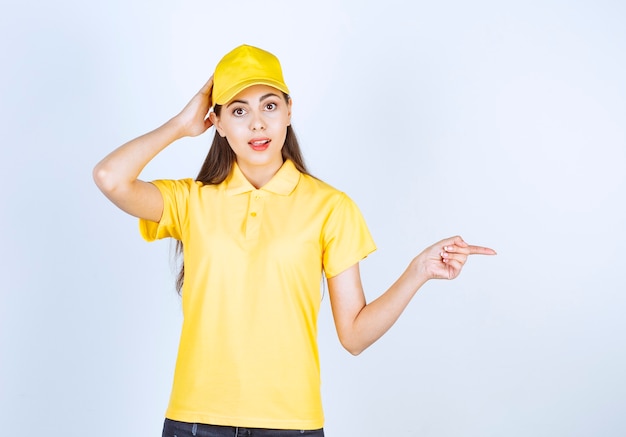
[224,159,300,196]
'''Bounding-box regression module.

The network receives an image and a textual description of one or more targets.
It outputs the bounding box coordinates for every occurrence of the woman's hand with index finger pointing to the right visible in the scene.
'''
[414,236,496,279]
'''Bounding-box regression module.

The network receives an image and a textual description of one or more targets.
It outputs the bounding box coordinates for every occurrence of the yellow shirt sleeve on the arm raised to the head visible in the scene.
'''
[139,179,193,241]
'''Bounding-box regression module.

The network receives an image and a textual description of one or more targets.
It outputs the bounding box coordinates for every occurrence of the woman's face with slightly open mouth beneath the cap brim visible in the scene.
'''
[212,85,291,173]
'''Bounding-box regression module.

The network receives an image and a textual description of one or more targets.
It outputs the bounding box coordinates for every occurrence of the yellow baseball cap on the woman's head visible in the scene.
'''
[212,44,289,105]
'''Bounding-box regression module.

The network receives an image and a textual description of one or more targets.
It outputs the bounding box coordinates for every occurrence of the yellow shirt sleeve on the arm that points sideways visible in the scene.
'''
[322,193,376,278]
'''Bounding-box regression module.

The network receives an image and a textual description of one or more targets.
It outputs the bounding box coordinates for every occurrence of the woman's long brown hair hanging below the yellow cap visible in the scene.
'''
[176,93,310,294]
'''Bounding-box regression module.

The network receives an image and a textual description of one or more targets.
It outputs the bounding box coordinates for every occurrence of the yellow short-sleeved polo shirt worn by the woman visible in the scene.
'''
[140,161,375,429]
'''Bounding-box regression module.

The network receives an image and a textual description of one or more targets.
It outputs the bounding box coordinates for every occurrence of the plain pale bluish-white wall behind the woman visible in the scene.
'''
[0,0,626,437]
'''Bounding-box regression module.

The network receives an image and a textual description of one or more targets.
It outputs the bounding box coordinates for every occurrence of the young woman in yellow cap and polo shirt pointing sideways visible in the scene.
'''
[94,45,495,437]
